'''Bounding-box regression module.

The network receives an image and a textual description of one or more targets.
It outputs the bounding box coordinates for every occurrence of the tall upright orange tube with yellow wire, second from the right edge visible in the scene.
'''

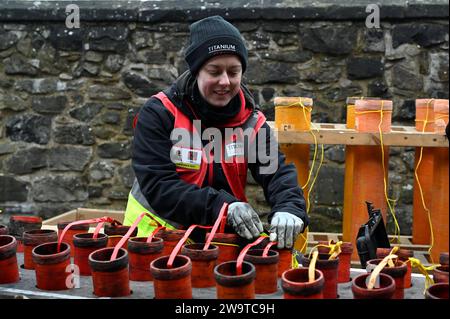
[412,99,434,245]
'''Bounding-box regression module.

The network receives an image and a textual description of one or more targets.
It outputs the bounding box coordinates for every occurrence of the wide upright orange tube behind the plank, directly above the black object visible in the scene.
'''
[343,100,392,261]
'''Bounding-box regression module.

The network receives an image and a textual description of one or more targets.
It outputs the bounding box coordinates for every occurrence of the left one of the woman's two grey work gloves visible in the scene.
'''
[227,202,263,240]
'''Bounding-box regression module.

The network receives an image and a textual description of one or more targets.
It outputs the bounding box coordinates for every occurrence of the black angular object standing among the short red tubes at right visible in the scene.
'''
[356,201,391,268]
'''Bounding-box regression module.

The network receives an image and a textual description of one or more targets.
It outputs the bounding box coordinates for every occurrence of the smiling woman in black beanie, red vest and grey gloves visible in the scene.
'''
[124,16,308,248]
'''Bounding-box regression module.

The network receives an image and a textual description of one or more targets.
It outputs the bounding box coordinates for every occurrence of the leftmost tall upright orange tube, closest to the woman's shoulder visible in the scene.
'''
[274,97,313,253]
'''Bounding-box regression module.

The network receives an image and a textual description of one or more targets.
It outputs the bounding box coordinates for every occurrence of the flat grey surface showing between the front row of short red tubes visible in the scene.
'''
[0,253,425,299]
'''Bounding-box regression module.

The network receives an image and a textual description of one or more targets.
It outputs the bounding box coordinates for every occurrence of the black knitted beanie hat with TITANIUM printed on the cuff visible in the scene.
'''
[184,16,247,74]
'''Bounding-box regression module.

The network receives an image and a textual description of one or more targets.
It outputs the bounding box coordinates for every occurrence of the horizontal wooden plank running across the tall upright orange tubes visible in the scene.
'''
[268,121,449,147]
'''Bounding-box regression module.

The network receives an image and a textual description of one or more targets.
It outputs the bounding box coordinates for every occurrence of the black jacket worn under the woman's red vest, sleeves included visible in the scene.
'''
[132,72,308,232]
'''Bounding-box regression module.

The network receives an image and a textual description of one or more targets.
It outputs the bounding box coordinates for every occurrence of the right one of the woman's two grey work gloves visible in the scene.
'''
[270,212,304,249]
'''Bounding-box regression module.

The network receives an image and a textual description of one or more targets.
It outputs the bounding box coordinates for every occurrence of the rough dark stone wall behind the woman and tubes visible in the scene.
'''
[0,0,448,234]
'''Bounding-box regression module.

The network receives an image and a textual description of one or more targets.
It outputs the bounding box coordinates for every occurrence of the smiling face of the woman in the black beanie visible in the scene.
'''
[197,54,242,107]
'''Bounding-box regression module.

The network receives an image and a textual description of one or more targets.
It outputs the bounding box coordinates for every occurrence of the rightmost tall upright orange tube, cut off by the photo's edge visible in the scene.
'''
[430,100,449,263]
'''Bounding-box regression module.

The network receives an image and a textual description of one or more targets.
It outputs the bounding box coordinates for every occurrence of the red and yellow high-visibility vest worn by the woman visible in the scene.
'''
[124,90,266,237]
